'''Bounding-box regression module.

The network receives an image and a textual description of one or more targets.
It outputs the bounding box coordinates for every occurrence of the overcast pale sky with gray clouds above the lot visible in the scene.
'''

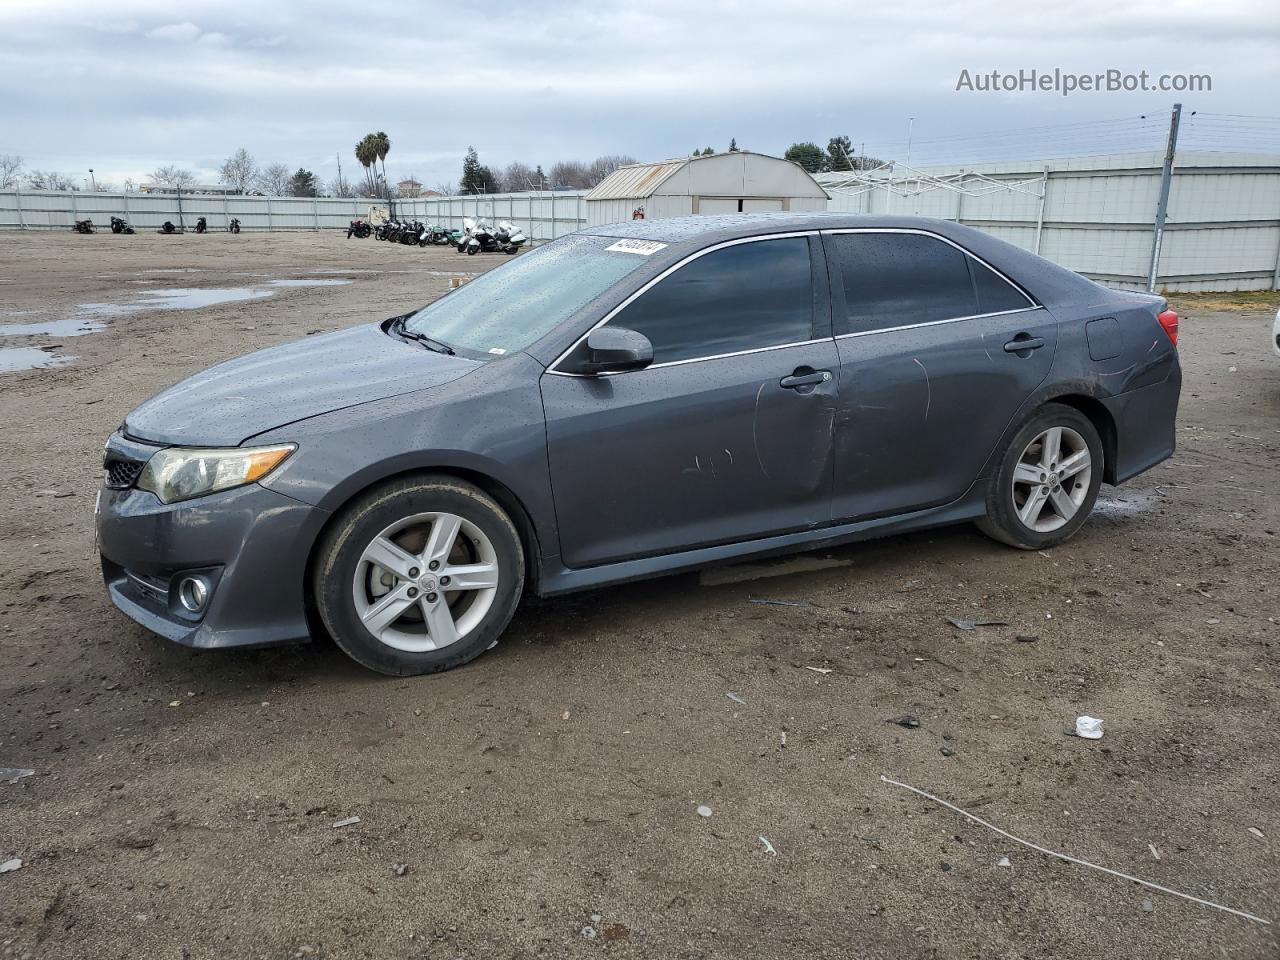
[0,0,1280,186]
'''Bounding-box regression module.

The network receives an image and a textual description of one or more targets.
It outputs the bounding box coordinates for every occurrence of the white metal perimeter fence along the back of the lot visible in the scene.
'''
[0,151,1280,292]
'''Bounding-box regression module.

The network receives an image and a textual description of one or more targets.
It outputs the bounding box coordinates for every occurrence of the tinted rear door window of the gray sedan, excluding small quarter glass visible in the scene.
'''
[826,233,972,334]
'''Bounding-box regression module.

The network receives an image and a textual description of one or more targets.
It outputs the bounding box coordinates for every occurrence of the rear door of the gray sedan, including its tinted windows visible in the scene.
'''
[823,230,1057,521]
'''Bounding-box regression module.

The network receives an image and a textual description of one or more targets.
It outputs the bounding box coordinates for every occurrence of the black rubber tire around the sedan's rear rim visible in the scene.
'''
[977,403,1105,550]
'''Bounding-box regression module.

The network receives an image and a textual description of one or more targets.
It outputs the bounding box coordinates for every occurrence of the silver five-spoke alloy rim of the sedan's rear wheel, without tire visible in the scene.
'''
[1010,426,1093,534]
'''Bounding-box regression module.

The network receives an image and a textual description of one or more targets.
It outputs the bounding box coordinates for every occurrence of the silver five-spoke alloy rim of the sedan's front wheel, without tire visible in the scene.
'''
[352,513,498,653]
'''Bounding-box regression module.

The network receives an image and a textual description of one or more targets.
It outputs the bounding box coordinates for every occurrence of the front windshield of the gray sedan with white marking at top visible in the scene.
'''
[404,236,657,356]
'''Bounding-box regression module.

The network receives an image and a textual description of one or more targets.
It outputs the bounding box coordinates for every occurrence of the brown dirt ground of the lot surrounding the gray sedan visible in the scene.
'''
[0,233,1280,960]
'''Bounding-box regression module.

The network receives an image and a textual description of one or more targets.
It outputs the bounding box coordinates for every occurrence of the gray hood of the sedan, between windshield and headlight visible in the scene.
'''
[124,324,479,447]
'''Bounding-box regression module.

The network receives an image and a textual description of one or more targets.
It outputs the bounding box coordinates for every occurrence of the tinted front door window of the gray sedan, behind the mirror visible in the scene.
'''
[609,237,813,364]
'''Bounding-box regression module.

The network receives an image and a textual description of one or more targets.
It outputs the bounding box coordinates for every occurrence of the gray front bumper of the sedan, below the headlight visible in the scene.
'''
[97,471,328,648]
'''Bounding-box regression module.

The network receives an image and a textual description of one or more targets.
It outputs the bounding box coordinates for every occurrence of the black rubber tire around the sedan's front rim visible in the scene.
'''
[312,474,525,677]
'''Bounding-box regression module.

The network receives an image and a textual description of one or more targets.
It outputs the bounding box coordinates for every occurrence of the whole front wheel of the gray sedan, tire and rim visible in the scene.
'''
[314,475,525,677]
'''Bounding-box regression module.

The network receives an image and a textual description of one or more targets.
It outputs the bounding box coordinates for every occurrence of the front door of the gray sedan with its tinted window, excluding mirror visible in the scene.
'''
[541,234,838,567]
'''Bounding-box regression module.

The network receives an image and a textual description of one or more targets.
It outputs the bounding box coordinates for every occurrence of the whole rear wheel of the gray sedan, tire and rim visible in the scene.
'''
[978,403,1105,550]
